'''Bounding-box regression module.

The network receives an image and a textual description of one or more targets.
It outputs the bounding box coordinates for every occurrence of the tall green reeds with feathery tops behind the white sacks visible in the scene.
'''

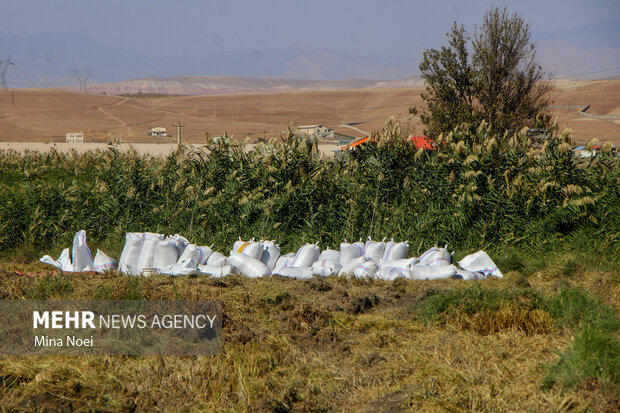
[0,119,620,258]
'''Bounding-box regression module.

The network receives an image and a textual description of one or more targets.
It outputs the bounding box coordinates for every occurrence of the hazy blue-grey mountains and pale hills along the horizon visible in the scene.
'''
[0,20,620,94]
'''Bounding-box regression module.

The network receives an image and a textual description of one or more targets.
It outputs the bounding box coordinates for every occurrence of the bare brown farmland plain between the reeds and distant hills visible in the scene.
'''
[0,79,620,148]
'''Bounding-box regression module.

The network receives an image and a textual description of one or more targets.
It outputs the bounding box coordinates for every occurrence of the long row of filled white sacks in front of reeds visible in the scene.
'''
[41,230,503,280]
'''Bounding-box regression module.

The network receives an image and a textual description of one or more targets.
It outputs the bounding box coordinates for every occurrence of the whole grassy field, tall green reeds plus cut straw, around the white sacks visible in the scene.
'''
[0,120,620,412]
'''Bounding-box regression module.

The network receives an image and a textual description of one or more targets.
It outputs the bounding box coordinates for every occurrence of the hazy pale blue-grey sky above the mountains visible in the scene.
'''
[0,0,620,57]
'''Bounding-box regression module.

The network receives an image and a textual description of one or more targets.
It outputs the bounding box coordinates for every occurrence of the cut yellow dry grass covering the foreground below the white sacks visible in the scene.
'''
[0,258,620,412]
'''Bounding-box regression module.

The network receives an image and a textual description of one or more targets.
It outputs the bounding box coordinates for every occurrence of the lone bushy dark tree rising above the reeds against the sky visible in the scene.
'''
[410,6,550,138]
